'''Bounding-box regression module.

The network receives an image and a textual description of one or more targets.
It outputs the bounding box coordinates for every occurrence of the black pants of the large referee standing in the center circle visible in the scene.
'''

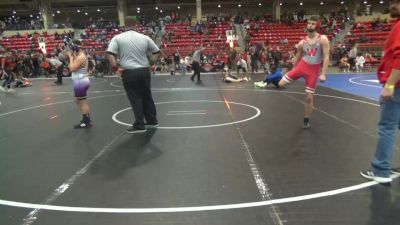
[122,67,158,129]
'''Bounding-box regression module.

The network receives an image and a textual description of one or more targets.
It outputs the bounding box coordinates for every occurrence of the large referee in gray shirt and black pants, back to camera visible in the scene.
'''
[107,17,160,133]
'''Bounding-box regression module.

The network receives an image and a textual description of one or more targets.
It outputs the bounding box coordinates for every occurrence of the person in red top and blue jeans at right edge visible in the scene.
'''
[360,0,400,183]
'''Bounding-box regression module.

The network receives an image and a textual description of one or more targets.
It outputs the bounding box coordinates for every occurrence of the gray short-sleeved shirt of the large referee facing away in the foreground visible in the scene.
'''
[107,30,160,69]
